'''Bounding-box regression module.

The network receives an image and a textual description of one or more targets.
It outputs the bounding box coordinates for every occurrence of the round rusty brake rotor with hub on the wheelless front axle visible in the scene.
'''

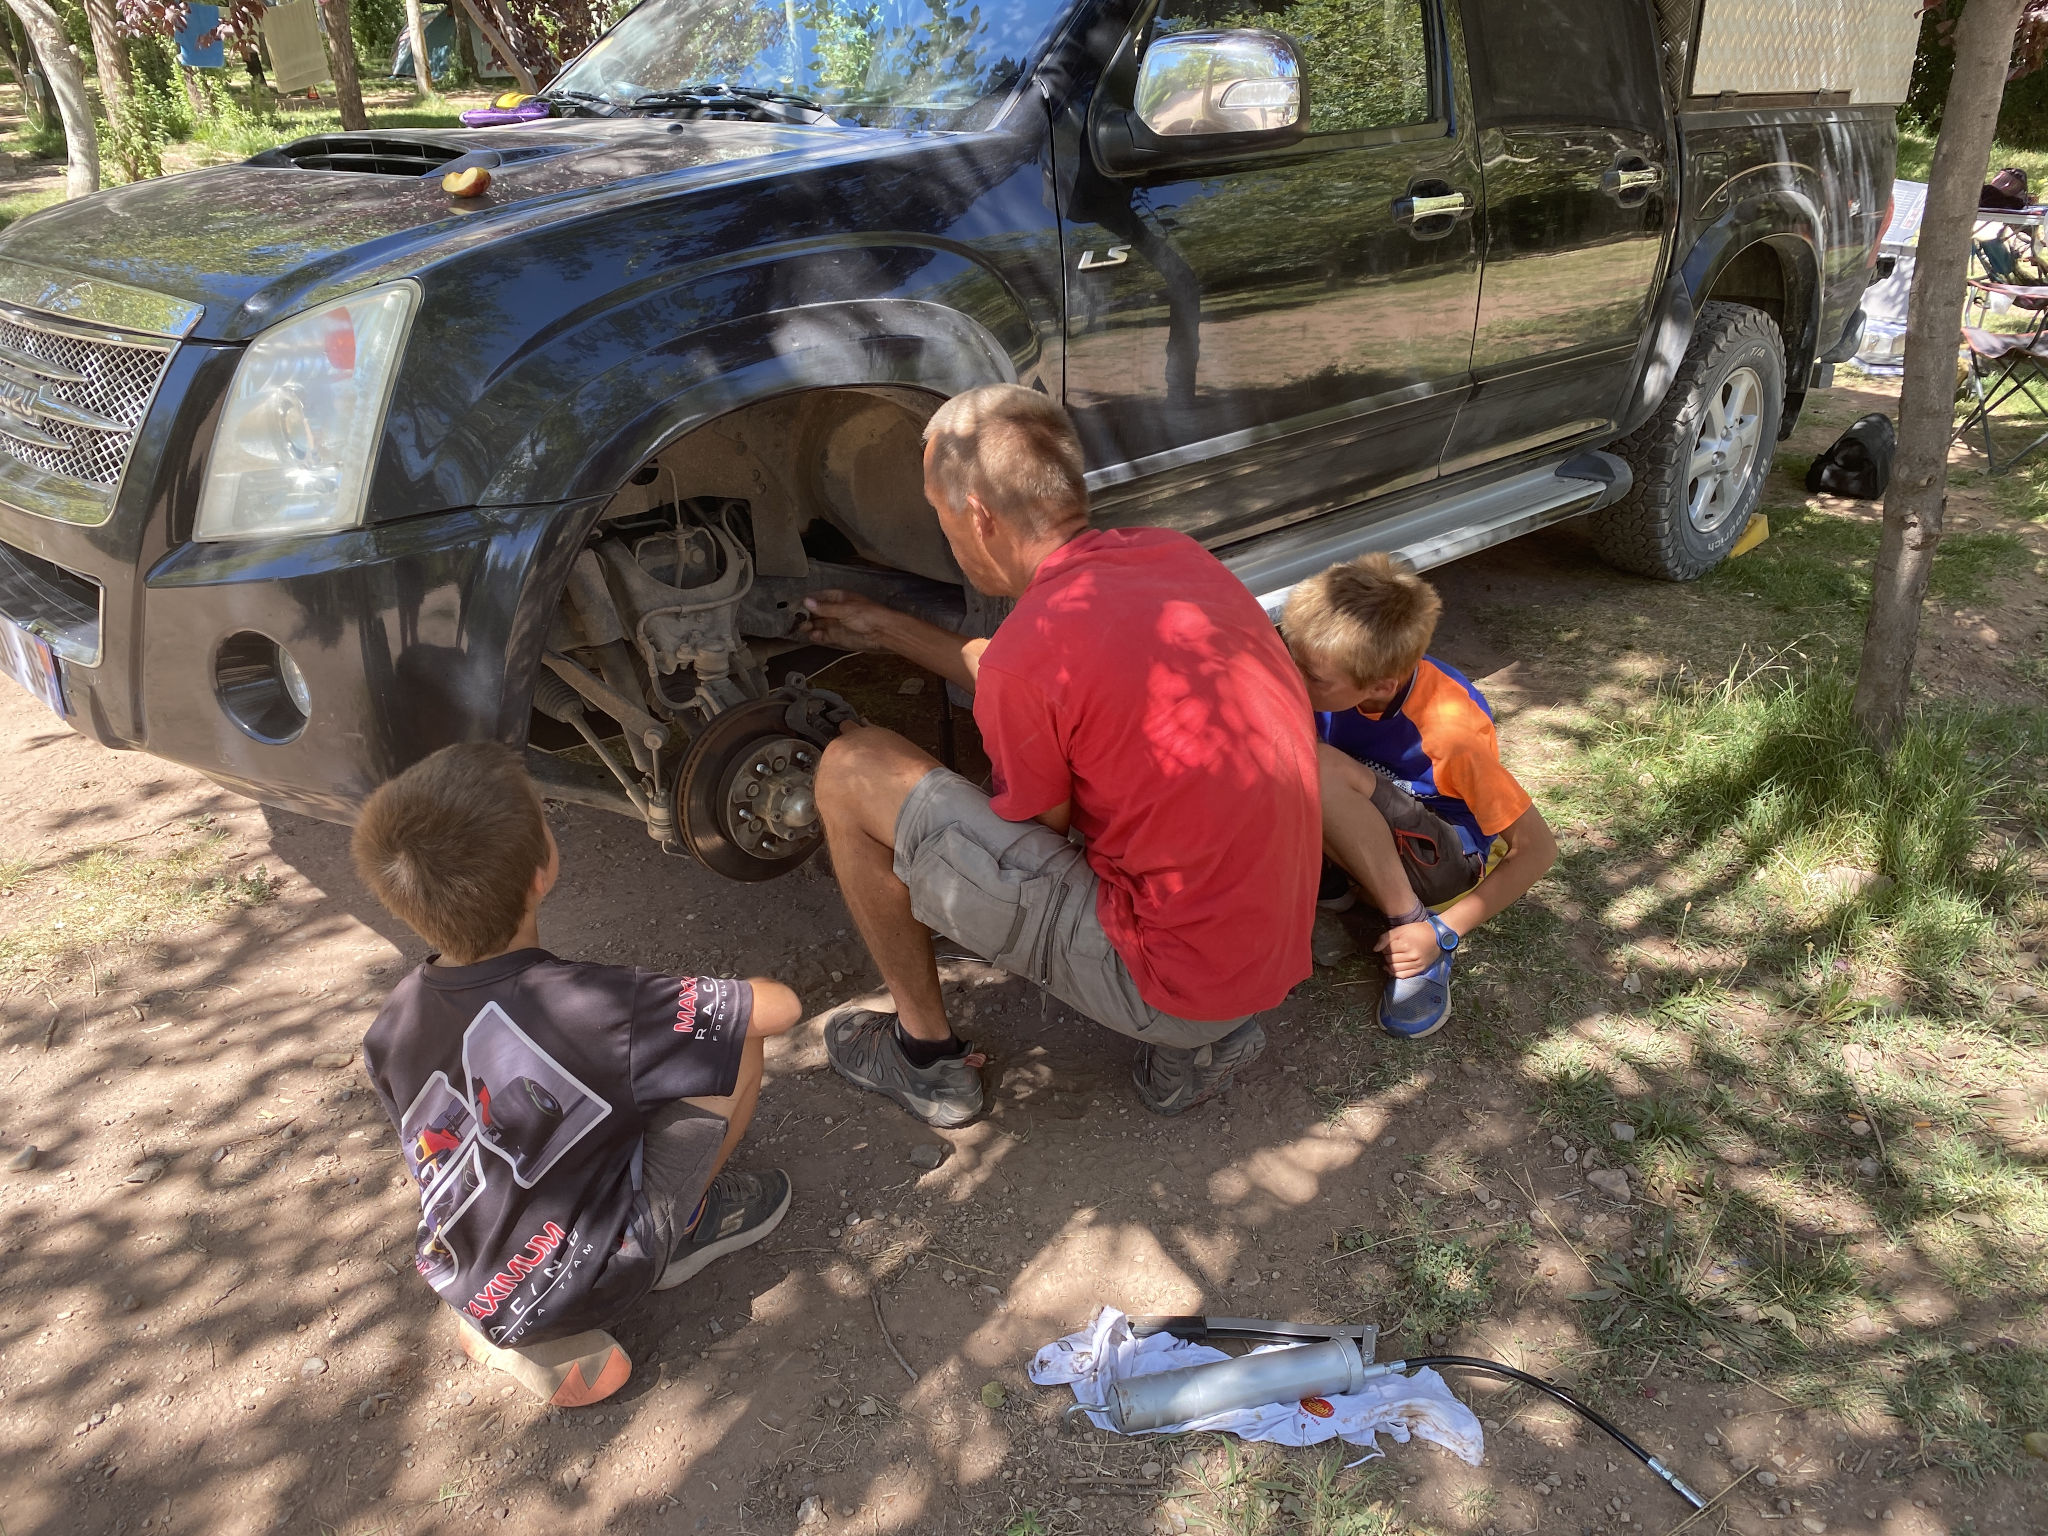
[674,698,827,881]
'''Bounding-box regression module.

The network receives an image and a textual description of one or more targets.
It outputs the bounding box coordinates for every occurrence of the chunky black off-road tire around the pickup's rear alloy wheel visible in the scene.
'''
[1587,299,1784,582]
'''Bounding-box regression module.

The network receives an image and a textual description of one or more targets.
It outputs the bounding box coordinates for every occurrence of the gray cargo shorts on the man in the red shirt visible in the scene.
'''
[895,768,1249,1051]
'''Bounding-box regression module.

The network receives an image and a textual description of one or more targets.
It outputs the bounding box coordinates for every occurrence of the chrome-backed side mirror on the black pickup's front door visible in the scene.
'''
[1094,29,1309,174]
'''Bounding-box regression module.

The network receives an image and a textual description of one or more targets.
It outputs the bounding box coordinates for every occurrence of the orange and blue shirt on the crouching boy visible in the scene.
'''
[1315,655,1532,858]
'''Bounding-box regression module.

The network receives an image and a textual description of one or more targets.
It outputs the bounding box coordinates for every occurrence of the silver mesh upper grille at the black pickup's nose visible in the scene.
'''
[0,311,170,494]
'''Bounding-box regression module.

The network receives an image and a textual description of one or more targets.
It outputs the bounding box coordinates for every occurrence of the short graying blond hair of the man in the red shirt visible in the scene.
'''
[924,385,1087,535]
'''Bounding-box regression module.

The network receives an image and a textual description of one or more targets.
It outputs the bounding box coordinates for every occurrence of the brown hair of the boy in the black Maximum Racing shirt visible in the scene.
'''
[348,741,547,965]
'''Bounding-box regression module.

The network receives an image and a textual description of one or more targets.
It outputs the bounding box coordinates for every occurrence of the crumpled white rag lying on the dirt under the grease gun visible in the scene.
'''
[1030,1307,1485,1466]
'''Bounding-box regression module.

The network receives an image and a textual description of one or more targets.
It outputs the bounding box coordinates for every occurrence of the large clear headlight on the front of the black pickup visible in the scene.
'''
[193,283,420,539]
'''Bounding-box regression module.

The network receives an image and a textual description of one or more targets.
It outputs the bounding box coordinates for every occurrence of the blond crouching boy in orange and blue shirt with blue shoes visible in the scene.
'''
[1280,555,1556,1040]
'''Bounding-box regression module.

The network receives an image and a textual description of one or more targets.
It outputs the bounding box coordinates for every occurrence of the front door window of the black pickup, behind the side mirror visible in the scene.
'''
[1153,0,1438,133]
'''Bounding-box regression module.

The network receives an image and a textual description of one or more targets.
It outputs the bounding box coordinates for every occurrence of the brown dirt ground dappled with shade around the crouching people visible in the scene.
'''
[0,376,2048,1536]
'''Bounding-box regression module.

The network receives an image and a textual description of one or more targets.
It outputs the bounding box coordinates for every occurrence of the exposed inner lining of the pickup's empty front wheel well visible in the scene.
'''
[602,385,961,582]
